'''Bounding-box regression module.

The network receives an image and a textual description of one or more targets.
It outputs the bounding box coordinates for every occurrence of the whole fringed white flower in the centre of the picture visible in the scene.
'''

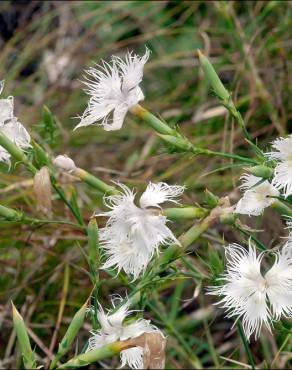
[98,183,184,280]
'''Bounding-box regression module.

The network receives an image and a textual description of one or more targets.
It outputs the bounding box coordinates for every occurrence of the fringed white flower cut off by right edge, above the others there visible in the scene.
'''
[267,135,292,198]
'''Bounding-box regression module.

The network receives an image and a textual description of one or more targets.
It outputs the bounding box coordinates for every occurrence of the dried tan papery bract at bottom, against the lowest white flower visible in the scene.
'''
[129,332,167,369]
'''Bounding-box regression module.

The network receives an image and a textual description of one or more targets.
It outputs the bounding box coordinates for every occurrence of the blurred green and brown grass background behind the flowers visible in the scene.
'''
[0,1,292,368]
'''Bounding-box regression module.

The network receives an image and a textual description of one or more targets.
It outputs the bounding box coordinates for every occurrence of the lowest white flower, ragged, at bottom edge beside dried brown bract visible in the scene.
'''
[87,301,163,369]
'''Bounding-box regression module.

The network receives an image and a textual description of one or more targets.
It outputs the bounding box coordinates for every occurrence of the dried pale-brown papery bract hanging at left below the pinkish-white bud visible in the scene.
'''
[33,166,52,217]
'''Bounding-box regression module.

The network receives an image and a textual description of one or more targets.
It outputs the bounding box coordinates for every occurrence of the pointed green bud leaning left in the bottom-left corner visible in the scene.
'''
[11,302,37,369]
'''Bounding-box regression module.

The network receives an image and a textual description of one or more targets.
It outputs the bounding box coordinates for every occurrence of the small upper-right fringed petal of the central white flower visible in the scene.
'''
[140,182,184,208]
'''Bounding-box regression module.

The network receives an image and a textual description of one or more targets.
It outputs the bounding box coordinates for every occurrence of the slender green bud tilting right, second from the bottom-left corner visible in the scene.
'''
[50,302,87,369]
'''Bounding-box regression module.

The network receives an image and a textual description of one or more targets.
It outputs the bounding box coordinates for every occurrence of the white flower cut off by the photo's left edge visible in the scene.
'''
[0,81,31,164]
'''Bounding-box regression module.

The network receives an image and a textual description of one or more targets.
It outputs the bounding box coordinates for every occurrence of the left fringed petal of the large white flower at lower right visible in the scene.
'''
[208,244,270,339]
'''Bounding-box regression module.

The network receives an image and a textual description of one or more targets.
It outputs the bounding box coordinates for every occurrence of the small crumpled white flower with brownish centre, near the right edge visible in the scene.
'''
[234,174,280,216]
